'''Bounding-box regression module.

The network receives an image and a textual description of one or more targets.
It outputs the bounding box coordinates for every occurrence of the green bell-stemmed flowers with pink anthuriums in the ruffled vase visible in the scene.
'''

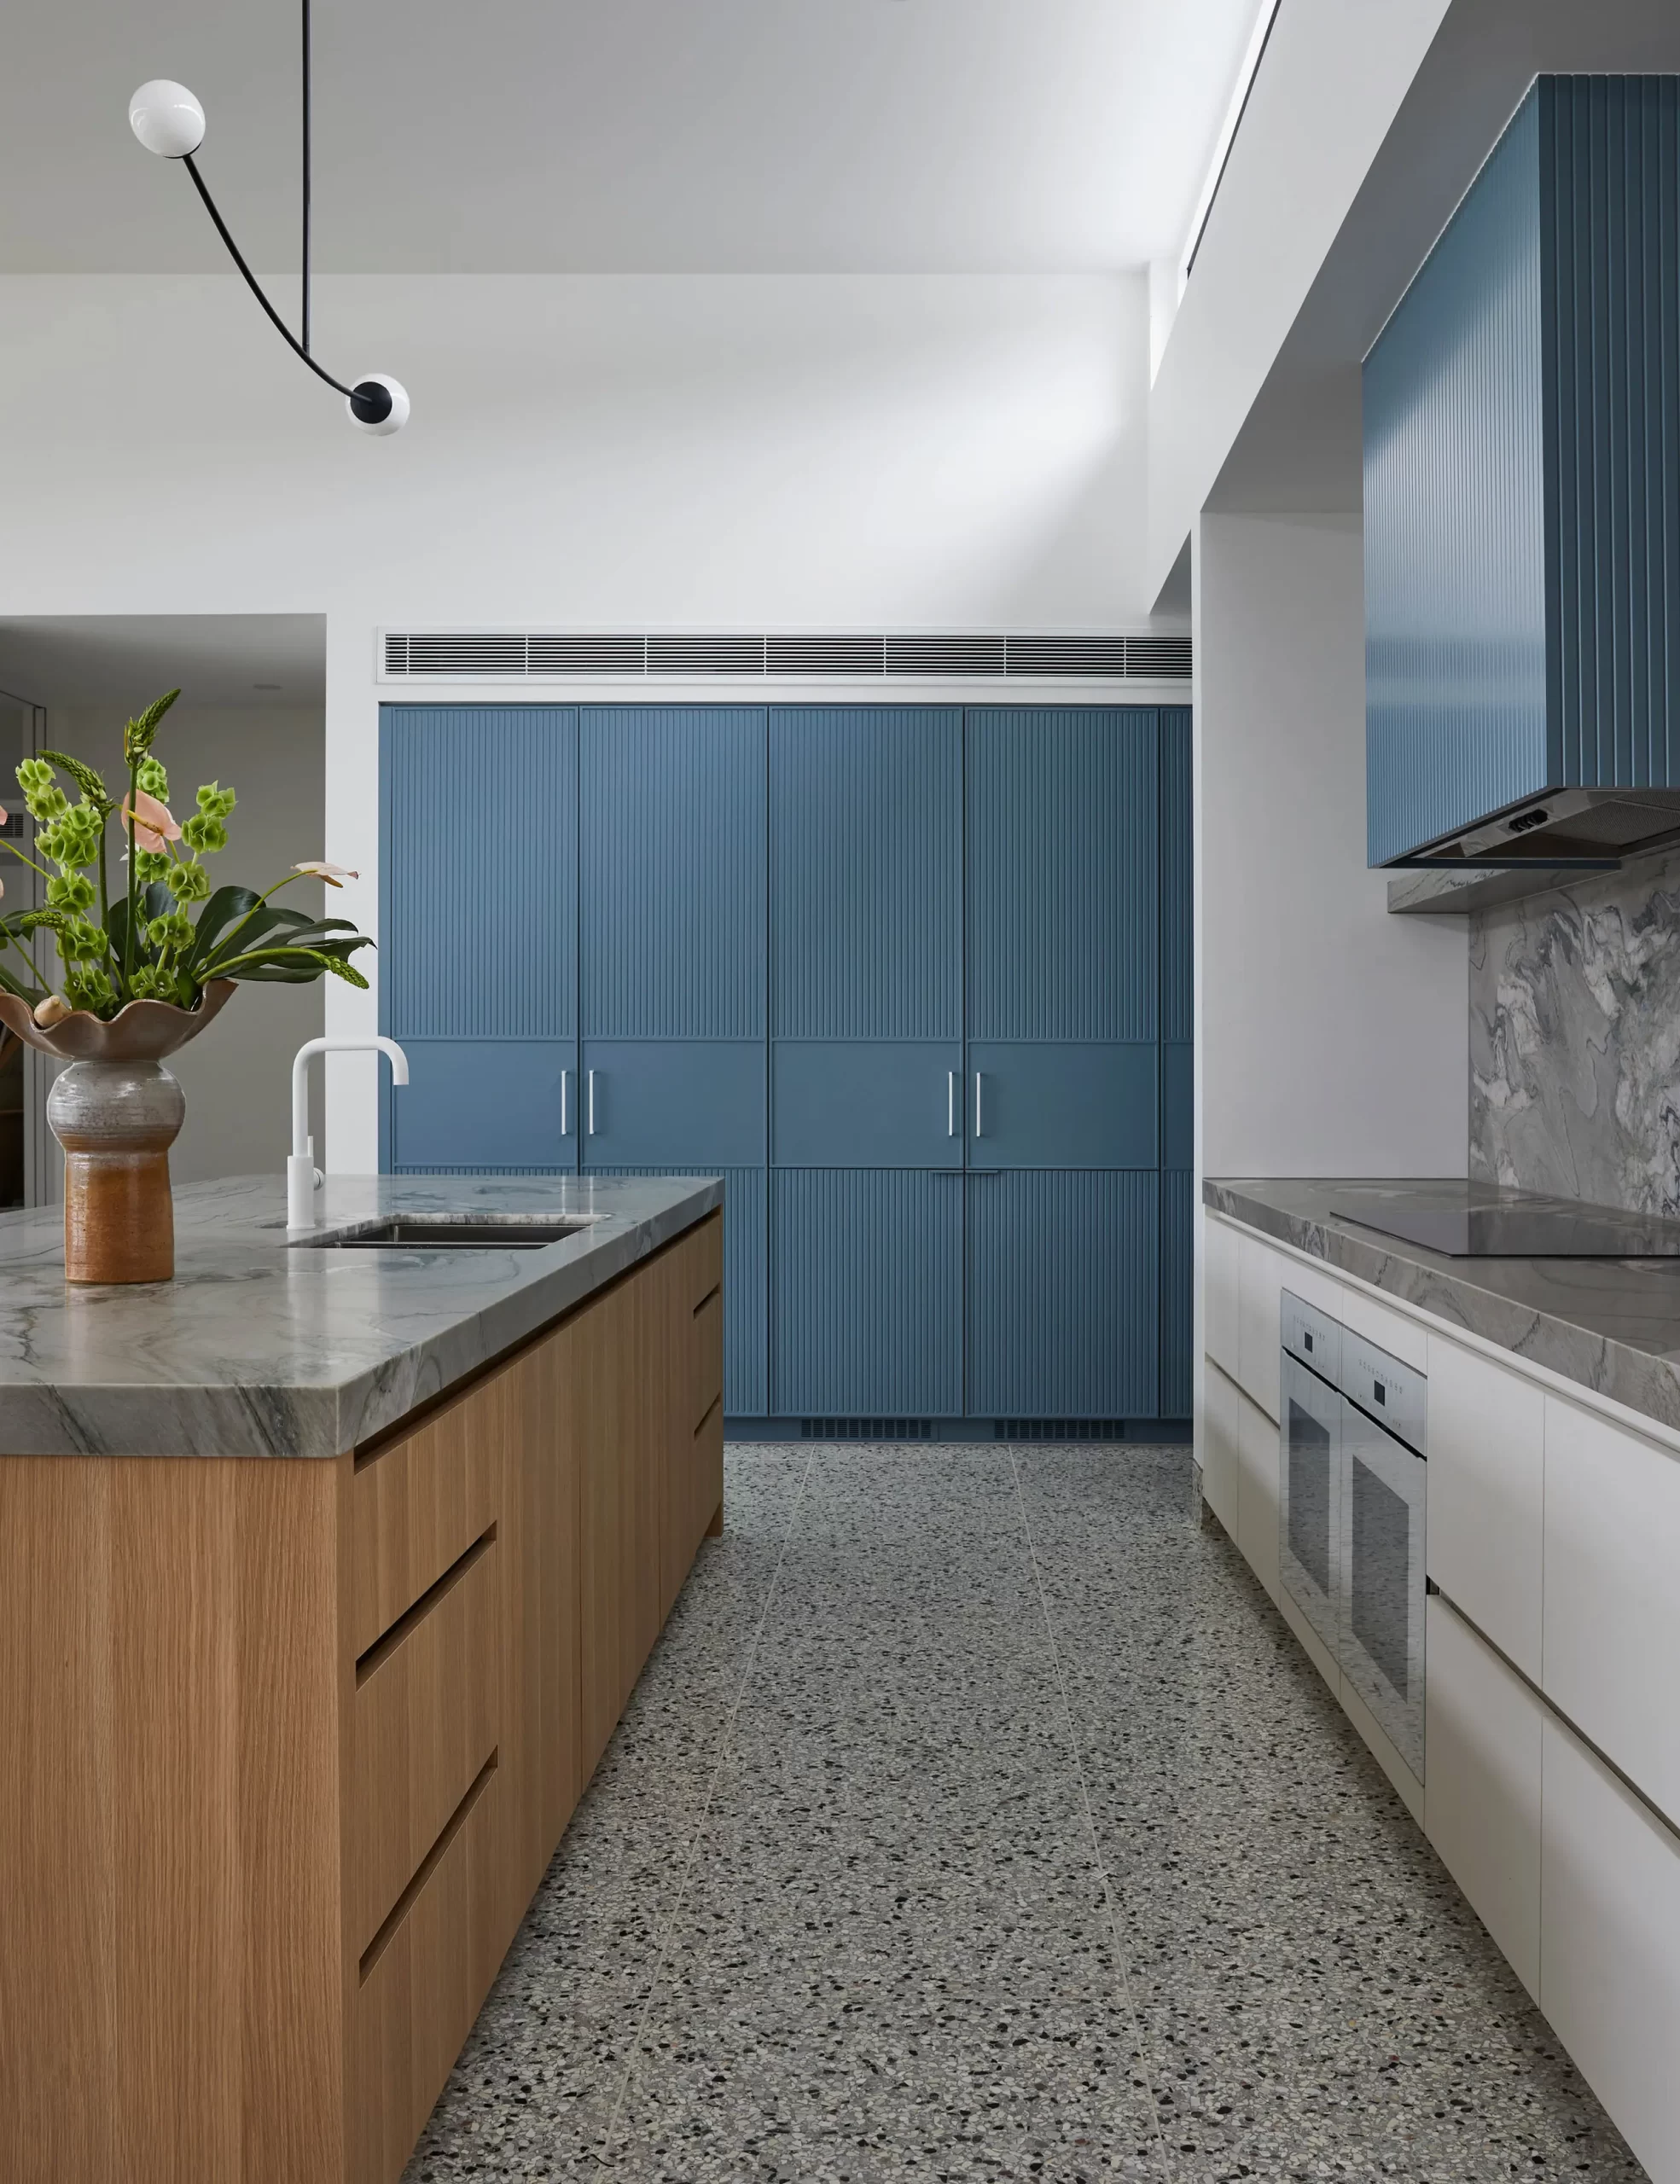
[0,690,374,1029]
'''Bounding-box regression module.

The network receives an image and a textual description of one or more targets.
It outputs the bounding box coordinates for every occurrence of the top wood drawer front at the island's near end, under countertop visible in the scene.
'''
[350,1372,507,1655]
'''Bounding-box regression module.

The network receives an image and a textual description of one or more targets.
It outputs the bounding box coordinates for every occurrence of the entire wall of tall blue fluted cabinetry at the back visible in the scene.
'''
[381,706,1193,1422]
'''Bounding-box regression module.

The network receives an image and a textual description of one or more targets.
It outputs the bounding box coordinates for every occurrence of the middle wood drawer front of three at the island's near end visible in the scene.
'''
[347,1529,503,1953]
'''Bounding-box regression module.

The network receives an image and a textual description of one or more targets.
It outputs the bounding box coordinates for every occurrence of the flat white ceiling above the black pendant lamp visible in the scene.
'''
[0,0,1256,273]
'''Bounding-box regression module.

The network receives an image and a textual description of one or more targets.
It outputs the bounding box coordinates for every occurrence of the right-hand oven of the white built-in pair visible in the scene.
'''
[1337,1330,1429,1782]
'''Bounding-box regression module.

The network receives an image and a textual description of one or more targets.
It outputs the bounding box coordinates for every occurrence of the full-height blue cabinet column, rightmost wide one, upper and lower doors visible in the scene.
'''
[966,707,1160,1420]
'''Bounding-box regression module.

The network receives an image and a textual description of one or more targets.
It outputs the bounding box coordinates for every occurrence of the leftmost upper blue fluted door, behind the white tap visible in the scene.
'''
[381,706,577,1175]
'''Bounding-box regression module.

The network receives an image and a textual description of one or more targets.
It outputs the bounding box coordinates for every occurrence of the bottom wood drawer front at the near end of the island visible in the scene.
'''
[346,1760,507,2184]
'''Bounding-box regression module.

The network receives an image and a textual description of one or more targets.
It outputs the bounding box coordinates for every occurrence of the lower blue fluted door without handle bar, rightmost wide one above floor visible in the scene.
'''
[966,1169,1160,1420]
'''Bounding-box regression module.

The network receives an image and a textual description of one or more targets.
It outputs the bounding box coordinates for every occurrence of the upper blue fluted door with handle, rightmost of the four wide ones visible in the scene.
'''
[966,706,1160,1169]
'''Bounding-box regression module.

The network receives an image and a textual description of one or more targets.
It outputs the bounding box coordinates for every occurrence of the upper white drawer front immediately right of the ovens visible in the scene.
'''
[1424,1334,1547,1684]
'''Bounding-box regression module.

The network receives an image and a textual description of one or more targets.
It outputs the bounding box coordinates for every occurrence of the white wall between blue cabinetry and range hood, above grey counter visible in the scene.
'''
[1195,515,1470,1177]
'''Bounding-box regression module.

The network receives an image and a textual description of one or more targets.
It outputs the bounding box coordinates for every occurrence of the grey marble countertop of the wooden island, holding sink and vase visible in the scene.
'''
[0,1175,724,1457]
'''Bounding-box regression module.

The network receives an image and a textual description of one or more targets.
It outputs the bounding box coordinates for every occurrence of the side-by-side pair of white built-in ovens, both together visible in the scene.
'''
[1278,1291,1429,1782]
